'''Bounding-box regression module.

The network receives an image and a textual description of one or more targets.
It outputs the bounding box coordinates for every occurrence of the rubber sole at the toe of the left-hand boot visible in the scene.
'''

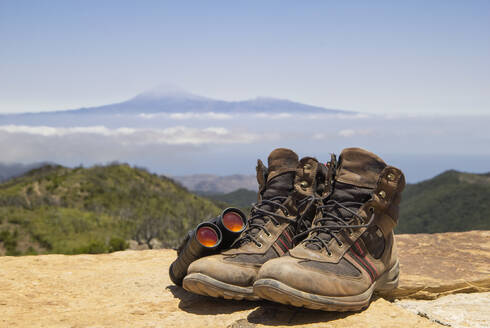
[182,273,260,301]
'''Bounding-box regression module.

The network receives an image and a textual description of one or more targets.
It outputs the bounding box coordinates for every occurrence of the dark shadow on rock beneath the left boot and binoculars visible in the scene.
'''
[166,285,263,315]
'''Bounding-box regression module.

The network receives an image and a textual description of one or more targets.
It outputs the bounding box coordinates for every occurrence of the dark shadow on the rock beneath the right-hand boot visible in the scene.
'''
[247,301,357,326]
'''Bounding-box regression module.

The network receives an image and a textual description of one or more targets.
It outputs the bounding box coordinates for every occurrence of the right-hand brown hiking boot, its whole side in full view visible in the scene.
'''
[254,148,405,311]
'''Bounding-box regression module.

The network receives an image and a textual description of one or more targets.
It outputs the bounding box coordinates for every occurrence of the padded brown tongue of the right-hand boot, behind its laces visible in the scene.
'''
[306,148,386,249]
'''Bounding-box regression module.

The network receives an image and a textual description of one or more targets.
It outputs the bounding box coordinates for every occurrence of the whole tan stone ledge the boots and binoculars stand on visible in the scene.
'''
[0,231,490,328]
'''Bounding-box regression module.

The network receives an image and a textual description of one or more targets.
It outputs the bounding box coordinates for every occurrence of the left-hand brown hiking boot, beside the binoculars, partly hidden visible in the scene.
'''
[183,148,329,300]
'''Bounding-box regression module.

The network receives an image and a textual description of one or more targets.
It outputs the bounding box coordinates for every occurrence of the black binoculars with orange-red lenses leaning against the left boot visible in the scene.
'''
[169,207,247,286]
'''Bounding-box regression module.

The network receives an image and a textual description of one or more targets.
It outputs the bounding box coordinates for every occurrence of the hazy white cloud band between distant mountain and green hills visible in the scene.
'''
[0,114,490,179]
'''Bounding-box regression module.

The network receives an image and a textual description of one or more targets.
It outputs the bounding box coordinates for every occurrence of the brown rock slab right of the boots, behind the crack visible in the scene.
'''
[394,231,490,299]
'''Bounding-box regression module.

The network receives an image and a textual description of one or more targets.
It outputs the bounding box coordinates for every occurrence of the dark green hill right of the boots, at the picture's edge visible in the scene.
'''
[396,171,490,233]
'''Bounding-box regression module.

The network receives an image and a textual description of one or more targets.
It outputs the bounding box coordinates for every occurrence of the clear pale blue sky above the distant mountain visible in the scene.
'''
[0,0,490,115]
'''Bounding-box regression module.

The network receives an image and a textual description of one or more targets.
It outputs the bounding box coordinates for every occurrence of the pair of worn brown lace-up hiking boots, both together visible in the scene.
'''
[183,148,405,311]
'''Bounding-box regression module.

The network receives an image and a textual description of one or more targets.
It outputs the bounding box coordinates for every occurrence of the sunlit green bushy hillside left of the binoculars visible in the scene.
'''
[0,164,220,255]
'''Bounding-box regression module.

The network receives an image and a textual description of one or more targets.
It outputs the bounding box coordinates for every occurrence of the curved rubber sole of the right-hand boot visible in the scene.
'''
[253,261,400,312]
